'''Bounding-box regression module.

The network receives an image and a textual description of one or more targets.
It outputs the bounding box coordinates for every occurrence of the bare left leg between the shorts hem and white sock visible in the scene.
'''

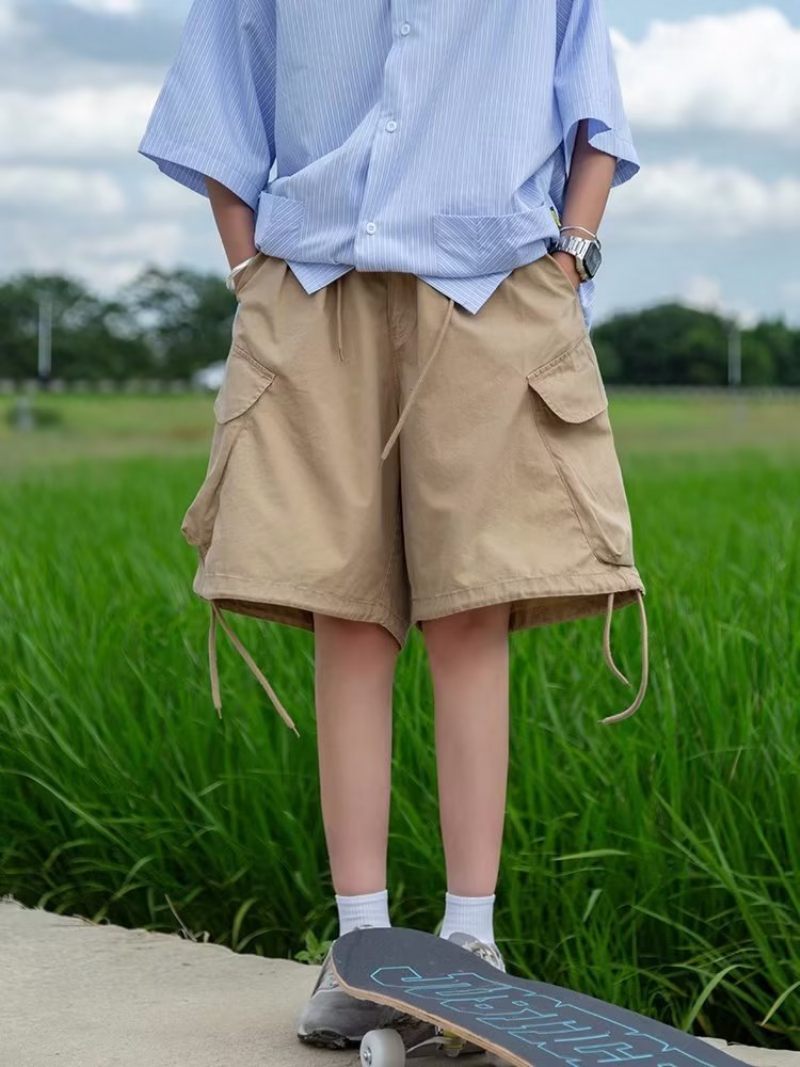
[314,614,399,895]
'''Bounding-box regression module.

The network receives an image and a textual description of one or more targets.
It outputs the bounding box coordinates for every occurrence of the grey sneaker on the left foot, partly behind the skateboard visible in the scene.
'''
[297,923,398,1049]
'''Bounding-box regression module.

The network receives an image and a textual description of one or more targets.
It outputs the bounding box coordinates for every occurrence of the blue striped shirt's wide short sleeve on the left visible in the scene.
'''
[139,0,275,210]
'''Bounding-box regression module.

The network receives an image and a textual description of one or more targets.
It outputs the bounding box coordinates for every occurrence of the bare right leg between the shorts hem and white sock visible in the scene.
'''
[422,604,510,896]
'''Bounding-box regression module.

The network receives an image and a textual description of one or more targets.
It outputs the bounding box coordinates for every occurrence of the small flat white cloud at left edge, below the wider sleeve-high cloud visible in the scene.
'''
[0,166,125,216]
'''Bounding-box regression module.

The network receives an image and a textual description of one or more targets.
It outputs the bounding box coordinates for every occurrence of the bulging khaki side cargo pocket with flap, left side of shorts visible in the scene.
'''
[180,344,275,559]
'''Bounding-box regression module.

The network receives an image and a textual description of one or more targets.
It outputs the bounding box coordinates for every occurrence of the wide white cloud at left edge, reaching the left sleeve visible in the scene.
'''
[0,84,157,160]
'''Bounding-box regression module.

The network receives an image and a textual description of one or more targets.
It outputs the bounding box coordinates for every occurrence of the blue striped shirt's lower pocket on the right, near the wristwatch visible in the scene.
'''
[433,203,559,277]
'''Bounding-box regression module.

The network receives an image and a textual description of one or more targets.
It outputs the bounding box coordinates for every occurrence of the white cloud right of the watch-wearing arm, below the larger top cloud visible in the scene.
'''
[608,159,800,241]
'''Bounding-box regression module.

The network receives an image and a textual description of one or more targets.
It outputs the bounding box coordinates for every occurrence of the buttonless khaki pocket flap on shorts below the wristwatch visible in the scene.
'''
[527,336,608,423]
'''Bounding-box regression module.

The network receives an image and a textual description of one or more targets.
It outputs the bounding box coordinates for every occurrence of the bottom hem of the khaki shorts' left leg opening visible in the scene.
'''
[192,572,411,649]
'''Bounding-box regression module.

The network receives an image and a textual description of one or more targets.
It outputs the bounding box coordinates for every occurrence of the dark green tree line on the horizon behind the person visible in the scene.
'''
[0,267,800,386]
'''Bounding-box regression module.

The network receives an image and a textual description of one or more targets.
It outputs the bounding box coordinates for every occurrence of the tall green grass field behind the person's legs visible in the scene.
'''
[0,394,800,1048]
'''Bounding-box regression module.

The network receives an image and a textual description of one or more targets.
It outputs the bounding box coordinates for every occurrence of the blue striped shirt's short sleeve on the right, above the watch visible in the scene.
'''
[555,0,641,188]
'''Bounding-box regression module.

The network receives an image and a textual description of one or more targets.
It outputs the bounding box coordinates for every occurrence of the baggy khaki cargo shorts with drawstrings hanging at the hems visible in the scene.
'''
[181,253,647,732]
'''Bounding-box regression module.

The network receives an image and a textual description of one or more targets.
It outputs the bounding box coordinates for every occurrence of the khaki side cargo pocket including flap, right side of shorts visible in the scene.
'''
[527,332,634,567]
